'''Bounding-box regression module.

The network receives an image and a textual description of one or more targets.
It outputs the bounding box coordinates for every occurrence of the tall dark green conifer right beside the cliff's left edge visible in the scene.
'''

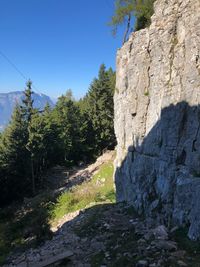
[87,64,115,153]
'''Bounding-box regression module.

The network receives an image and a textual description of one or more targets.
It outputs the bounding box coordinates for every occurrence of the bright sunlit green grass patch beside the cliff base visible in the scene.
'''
[51,162,115,224]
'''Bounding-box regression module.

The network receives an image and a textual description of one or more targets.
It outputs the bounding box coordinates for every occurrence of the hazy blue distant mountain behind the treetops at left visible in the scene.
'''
[0,91,54,131]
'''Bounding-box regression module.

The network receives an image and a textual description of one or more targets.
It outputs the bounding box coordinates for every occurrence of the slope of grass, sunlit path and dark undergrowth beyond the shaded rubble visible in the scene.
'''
[0,151,115,265]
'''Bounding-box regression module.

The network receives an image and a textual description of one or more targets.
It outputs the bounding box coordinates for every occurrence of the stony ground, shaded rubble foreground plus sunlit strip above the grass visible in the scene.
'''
[3,152,200,267]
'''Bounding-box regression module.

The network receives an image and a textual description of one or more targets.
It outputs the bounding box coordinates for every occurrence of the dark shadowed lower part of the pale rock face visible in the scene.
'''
[115,102,200,240]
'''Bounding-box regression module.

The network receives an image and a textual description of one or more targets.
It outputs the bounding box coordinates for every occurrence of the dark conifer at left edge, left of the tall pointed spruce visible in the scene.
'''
[0,106,29,204]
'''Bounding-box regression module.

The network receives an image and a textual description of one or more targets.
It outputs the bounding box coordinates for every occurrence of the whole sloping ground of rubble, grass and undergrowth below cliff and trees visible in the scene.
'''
[0,152,200,267]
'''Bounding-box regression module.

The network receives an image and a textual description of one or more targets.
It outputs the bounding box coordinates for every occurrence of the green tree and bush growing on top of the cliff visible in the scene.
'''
[109,0,155,43]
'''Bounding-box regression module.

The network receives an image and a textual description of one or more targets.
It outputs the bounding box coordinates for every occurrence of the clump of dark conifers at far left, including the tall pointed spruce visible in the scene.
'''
[0,81,55,206]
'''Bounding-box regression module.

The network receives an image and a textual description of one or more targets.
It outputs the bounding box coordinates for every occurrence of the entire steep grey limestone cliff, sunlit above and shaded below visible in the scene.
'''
[114,0,200,239]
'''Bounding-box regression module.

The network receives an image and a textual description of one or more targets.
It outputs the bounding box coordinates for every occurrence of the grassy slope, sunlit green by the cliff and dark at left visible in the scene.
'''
[0,162,115,265]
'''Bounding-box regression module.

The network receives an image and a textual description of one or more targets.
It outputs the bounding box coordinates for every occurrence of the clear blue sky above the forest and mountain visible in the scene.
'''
[0,0,122,98]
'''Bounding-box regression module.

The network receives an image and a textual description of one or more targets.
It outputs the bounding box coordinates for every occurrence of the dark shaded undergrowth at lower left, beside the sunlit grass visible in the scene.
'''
[0,194,52,265]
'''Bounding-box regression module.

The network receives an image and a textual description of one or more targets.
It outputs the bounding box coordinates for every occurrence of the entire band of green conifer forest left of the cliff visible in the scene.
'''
[0,64,116,206]
